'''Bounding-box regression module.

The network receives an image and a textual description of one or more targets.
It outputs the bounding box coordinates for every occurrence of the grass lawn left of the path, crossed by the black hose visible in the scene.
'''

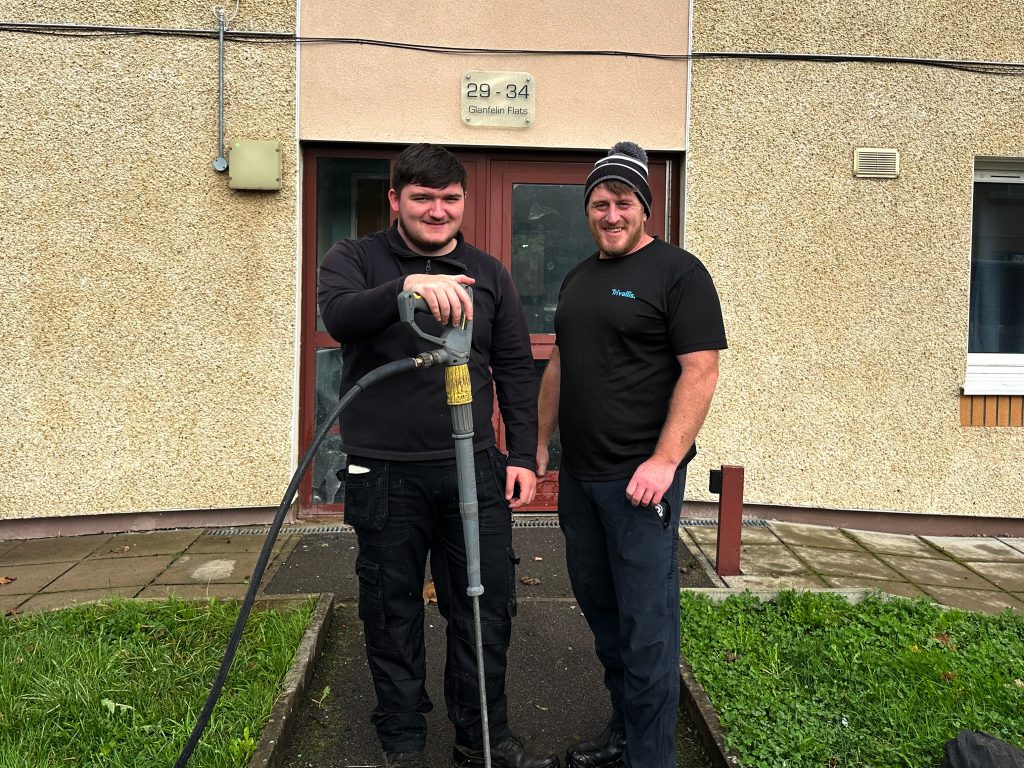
[0,599,313,768]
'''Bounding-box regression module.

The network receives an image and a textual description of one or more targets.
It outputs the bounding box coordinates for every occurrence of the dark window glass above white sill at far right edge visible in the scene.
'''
[968,182,1024,354]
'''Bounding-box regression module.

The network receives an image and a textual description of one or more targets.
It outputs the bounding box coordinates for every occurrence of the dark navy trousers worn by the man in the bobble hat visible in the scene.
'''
[558,467,686,768]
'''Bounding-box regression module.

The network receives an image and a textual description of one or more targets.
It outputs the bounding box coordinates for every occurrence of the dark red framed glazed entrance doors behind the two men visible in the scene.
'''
[298,145,675,519]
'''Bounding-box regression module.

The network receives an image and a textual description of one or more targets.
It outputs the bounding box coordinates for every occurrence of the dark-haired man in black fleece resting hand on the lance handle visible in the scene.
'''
[318,144,558,768]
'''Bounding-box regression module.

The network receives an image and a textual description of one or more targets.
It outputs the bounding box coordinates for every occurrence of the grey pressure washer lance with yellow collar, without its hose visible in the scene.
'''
[398,286,490,768]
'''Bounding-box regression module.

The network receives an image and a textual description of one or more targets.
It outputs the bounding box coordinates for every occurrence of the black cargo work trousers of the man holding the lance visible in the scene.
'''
[345,449,516,753]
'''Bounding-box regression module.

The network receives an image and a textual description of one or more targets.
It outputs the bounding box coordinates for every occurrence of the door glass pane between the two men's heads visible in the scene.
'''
[512,184,594,334]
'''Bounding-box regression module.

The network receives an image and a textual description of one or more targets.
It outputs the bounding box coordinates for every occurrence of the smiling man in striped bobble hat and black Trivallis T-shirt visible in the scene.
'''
[538,142,726,768]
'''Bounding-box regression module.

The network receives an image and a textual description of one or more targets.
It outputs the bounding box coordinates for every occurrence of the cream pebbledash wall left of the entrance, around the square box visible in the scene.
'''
[0,0,297,519]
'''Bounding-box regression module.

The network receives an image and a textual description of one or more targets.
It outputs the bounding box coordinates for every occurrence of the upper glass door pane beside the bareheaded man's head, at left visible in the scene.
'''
[316,158,390,331]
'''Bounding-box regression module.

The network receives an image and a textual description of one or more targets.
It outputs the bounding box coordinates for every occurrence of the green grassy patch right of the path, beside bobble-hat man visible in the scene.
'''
[681,591,1024,768]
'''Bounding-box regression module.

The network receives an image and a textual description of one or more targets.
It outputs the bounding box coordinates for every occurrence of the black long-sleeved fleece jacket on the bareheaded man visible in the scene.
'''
[317,224,537,469]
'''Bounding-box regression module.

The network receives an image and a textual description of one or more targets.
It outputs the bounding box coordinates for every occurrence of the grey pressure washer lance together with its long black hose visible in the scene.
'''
[174,287,490,768]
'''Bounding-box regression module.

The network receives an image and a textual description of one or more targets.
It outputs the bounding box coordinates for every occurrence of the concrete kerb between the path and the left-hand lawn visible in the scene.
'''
[247,592,334,768]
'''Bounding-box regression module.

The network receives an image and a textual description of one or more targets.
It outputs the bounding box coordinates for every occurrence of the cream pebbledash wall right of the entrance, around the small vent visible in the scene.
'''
[685,0,1024,517]
